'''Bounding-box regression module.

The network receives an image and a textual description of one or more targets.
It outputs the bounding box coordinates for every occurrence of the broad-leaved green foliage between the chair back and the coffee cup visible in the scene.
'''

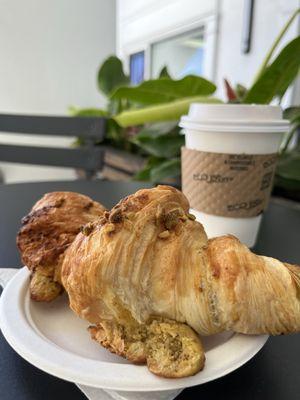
[70,56,220,182]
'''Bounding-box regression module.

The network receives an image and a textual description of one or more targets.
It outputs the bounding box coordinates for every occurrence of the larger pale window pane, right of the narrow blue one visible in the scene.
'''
[151,27,205,79]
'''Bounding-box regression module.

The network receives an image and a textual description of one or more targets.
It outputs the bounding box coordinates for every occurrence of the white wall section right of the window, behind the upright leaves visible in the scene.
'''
[216,0,299,101]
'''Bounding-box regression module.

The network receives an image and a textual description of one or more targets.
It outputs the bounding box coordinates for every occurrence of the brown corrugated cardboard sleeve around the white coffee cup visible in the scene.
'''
[181,147,277,218]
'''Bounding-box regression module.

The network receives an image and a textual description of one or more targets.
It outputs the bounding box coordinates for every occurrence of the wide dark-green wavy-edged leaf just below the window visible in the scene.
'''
[111,75,216,104]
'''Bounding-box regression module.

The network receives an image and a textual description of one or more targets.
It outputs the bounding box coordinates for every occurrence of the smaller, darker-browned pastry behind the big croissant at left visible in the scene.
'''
[17,192,105,301]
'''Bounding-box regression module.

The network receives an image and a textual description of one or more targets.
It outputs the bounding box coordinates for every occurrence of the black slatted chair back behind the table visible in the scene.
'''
[0,114,106,179]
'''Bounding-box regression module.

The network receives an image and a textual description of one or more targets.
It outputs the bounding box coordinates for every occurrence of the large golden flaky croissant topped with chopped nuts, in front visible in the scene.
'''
[62,186,300,377]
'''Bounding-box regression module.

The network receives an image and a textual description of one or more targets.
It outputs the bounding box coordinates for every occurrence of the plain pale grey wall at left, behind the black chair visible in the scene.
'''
[0,0,115,182]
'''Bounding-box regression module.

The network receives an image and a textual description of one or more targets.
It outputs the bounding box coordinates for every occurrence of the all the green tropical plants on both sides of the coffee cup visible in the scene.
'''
[72,9,300,188]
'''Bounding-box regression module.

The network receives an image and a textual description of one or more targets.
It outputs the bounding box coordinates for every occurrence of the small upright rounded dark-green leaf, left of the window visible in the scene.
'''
[98,56,130,95]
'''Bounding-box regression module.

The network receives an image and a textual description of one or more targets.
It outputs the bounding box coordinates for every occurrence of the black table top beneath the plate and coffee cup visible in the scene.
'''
[0,181,300,400]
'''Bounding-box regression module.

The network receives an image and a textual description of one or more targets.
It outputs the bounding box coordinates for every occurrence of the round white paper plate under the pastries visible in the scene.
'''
[0,268,268,391]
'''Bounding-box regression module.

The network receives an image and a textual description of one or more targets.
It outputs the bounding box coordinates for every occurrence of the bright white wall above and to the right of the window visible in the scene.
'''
[117,0,299,101]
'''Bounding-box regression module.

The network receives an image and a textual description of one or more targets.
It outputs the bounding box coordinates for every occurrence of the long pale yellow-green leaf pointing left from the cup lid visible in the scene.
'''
[114,96,222,127]
